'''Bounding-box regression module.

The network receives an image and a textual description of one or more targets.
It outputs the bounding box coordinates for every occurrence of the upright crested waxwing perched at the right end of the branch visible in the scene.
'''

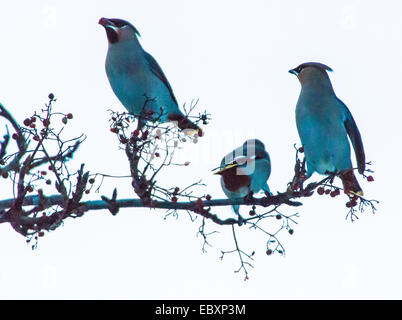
[289,62,366,195]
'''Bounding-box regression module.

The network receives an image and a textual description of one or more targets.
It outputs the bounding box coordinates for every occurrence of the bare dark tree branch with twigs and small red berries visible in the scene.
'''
[0,94,378,279]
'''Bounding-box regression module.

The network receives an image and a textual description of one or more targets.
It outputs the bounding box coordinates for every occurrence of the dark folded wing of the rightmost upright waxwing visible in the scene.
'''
[338,98,366,174]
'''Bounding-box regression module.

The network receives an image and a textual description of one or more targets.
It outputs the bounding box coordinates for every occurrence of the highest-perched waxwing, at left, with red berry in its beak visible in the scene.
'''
[99,18,202,136]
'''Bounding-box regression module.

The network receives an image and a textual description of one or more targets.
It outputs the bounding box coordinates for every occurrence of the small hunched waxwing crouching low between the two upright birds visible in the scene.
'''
[214,139,271,217]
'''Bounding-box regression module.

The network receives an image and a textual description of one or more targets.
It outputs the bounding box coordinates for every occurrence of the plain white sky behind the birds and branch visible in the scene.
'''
[0,0,402,299]
